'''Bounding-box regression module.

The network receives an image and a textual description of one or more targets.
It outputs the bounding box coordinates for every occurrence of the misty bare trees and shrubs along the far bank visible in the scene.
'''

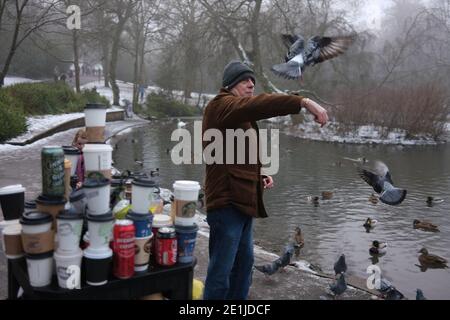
[0,0,450,135]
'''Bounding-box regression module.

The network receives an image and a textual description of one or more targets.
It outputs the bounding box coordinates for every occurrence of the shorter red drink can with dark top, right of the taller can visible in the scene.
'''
[156,227,177,266]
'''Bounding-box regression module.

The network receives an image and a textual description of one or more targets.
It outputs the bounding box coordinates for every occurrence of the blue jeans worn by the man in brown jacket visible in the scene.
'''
[203,206,253,300]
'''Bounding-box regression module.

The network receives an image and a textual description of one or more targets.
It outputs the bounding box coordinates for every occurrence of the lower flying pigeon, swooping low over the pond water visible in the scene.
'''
[358,161,407,206]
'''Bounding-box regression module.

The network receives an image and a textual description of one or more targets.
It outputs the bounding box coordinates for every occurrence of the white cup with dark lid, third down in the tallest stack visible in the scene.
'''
[83,179,111,215]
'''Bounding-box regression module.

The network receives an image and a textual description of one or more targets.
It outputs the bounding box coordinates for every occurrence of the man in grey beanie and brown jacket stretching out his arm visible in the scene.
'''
[202,61,328,300]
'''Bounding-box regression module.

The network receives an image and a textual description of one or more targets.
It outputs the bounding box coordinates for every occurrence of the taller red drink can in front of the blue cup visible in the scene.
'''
[113,220,135,279]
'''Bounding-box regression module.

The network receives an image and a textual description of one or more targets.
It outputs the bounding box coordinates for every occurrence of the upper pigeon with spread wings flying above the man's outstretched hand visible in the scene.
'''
[271,34,355,80]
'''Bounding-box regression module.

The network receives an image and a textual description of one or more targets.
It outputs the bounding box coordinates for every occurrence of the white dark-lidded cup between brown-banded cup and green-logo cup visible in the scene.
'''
[56,211,83,254]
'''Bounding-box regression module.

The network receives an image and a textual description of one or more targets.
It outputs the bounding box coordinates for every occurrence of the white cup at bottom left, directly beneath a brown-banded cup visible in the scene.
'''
[26,251,53,287]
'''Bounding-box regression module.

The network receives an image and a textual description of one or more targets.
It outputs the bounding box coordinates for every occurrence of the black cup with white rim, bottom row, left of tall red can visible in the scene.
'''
[83,246,113,286]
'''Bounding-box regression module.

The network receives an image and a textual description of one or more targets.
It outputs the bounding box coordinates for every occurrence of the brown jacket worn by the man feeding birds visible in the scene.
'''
[202,89,303,218]
